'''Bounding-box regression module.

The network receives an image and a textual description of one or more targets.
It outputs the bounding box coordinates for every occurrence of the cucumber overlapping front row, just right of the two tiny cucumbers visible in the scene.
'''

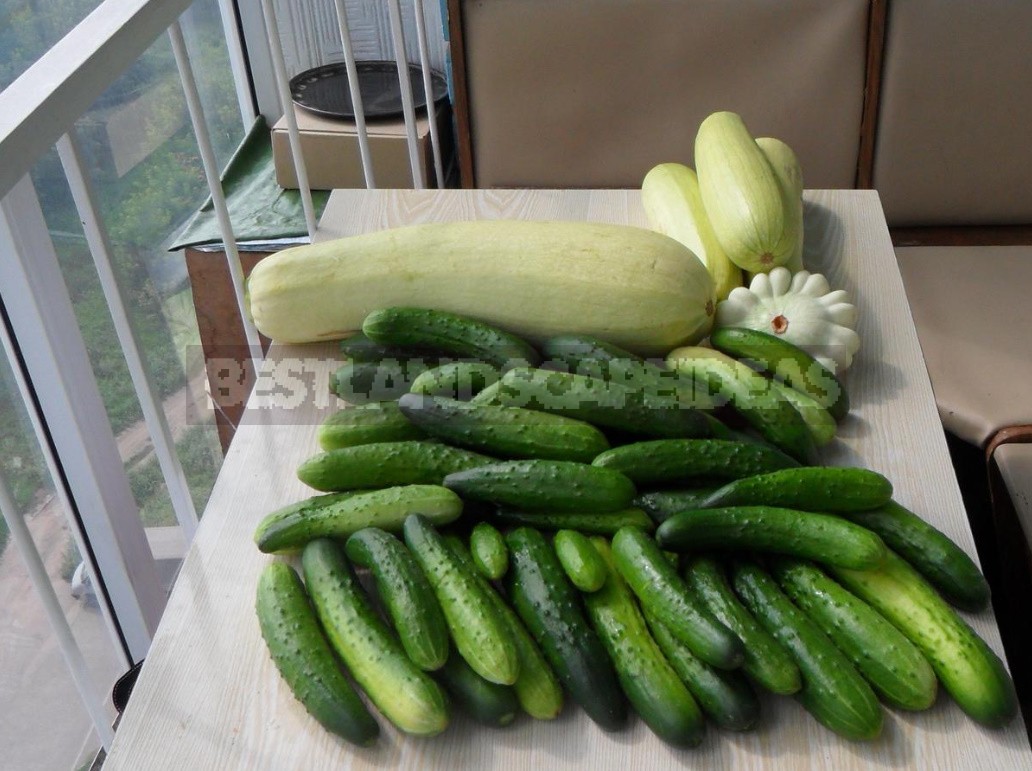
[612,527,745,669]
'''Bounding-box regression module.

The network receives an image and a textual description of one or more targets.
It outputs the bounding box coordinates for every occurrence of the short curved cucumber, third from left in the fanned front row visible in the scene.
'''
[345,527,449,671]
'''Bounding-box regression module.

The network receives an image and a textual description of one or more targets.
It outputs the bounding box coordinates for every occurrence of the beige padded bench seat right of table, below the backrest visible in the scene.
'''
[896,247,1032,446]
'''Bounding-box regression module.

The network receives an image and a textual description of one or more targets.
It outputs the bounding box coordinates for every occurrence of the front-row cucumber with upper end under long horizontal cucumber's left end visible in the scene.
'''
[684,556,803,696]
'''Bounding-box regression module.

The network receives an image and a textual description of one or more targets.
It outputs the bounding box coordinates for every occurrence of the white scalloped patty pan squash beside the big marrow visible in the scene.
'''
[715,267,860,373]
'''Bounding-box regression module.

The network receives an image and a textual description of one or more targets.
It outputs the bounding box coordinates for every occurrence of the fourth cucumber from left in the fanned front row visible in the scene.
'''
[404,514,519,685]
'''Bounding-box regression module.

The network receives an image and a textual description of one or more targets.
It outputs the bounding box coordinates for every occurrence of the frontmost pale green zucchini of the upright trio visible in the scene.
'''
[696,113,797,274]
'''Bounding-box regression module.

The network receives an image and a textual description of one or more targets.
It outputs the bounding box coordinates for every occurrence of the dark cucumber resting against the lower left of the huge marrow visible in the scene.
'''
[362,308,541,368]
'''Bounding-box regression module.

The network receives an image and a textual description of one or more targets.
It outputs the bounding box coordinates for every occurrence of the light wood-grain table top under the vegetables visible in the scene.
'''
[104,191,1032,771]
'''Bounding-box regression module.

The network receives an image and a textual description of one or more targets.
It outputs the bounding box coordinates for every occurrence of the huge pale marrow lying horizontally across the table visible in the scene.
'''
[248,220,715,355]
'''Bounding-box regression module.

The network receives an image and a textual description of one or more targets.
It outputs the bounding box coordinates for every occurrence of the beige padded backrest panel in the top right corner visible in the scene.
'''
[874,0,1032,225]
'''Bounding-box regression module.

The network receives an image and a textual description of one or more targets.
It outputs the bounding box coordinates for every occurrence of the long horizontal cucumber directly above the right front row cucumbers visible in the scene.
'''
[655,506,886,570]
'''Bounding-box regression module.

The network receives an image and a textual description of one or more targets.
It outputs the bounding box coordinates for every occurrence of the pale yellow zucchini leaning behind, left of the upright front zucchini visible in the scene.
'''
[642,163,742,300]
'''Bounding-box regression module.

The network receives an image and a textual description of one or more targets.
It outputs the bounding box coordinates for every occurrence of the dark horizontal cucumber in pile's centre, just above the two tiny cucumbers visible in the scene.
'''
[444,460,636,513]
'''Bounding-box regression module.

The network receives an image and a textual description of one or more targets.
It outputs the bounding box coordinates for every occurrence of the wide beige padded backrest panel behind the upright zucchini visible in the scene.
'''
[462,0,868,188]
